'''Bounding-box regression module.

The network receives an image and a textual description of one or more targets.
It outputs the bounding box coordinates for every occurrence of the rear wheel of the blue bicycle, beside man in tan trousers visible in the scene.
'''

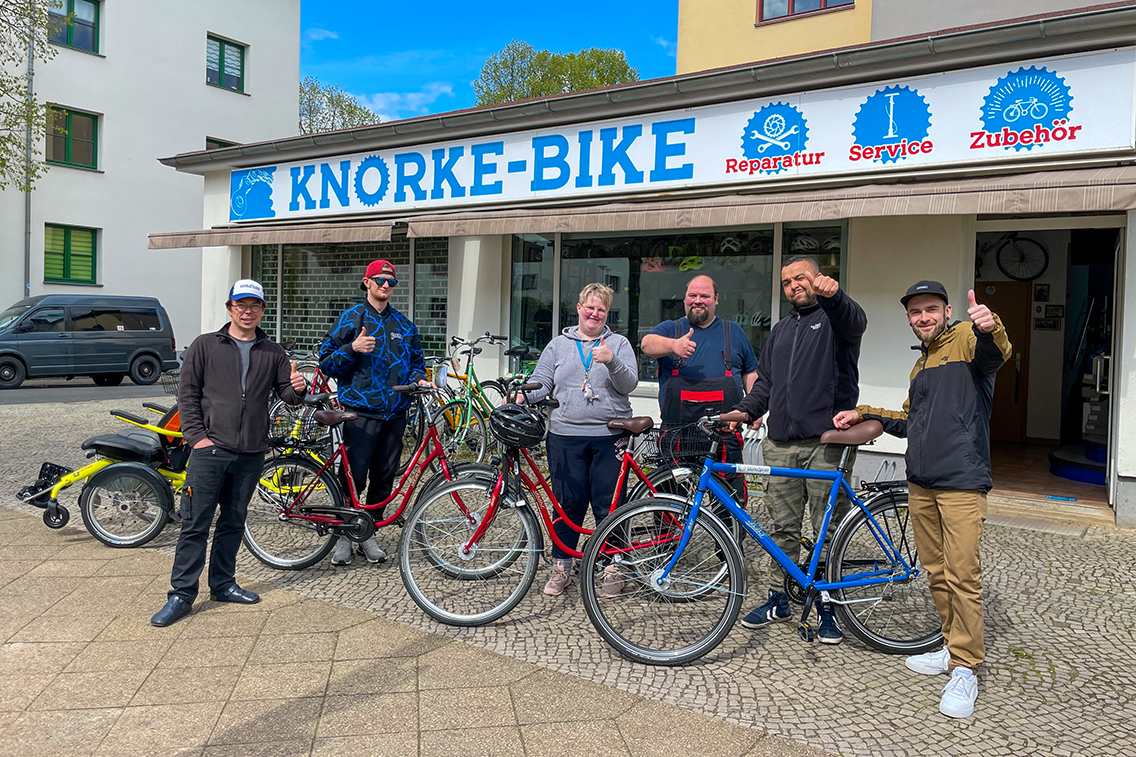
[826,492,943,655]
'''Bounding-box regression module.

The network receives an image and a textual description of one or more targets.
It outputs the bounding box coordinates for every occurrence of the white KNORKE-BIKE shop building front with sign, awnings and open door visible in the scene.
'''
[151,16,1136,525]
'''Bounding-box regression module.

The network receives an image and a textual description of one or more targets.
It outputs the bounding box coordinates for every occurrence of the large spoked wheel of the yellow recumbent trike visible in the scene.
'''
[78,464,174,548]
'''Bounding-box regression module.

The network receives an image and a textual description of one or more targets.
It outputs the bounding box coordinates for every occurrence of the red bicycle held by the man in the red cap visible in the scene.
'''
[244,385,494,571]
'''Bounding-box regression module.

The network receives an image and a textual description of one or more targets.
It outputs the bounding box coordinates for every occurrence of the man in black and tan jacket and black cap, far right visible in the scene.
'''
[833,281,1010,717]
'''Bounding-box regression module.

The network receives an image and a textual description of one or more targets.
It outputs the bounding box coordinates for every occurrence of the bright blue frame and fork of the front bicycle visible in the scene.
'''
[657,457,918,591]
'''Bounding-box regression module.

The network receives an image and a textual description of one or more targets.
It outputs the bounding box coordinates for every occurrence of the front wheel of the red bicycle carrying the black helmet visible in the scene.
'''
[399,479,541,626]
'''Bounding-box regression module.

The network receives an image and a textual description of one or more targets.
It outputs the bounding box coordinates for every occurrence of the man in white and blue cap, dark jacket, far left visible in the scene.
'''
[150,278,306,626]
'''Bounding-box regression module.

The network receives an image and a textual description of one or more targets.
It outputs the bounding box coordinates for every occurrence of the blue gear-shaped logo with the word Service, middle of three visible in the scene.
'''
[852,85,930,163]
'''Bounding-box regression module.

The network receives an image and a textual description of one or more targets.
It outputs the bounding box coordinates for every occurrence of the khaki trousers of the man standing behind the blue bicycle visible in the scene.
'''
[761,436,855,591]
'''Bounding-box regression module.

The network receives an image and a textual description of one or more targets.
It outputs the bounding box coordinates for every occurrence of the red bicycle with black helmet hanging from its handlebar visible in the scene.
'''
[399,384,678,626]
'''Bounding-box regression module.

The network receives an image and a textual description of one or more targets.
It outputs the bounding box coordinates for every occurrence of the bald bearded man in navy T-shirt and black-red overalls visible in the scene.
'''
[640,276,758,498]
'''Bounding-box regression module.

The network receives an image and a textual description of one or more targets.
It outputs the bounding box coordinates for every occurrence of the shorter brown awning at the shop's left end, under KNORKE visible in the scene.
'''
[150,221,391,250]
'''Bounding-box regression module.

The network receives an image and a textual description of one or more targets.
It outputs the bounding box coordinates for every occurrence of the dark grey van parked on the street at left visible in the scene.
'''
[0,294,177,389]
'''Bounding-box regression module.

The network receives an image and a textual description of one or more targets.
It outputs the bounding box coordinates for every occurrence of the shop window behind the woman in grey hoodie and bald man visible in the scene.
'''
[563,228,774,381]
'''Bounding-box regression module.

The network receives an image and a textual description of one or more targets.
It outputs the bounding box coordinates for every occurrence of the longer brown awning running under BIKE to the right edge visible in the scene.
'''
[408,166,1136,236]
